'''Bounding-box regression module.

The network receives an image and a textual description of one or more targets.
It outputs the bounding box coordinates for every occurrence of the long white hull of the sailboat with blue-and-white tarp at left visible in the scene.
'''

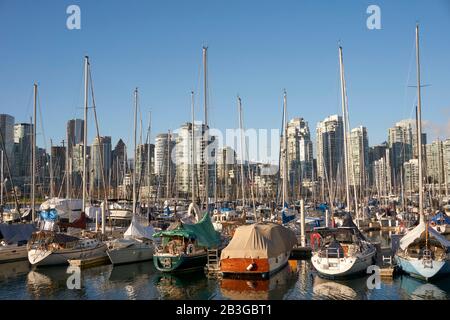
[28,243,106,267]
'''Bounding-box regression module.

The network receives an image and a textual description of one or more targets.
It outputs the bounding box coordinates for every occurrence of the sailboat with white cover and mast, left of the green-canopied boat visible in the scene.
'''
[106,88,154,265]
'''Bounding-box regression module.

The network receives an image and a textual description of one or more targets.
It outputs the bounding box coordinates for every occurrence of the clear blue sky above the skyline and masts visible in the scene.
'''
[0,0,450,159]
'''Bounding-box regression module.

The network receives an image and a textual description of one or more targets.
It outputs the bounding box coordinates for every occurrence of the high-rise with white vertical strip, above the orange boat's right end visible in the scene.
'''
[282,118,313,196]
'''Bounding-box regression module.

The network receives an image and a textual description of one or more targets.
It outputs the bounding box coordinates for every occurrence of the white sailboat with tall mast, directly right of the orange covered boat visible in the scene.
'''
[311,46,376,278]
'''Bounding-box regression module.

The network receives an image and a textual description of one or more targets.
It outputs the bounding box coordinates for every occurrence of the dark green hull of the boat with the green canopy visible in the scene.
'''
[153,252,208,272]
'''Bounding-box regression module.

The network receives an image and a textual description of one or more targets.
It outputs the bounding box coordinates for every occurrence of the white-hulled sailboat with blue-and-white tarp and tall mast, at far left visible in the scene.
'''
[27,56,106,266]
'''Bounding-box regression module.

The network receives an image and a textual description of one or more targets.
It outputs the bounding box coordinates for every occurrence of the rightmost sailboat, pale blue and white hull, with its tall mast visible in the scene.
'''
[395,25,450,281]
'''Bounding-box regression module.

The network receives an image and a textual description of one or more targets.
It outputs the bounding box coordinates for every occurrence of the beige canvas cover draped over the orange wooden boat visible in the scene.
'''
[220,222,297,259]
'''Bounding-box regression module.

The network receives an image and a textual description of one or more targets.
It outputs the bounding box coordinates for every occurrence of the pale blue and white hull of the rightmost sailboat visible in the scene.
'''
[395,255,450,281]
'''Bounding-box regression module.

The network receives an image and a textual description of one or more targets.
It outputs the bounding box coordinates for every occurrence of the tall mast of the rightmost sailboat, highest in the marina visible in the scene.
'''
[416,24,425,222]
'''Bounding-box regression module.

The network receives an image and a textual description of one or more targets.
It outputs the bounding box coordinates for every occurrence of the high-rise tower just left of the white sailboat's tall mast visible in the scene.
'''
[316,115,344,185]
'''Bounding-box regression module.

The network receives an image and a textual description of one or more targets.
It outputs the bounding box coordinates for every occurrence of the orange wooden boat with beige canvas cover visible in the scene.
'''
[220,222,297,278]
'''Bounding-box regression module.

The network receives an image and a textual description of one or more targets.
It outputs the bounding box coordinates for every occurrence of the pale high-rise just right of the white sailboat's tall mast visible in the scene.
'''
[348,126,369,188]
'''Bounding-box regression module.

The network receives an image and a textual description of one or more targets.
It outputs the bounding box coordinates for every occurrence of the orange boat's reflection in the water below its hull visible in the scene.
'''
[220,262,297,300]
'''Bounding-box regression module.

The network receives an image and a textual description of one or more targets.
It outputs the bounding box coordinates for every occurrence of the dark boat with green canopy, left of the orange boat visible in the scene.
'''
[153,214,220,272]
